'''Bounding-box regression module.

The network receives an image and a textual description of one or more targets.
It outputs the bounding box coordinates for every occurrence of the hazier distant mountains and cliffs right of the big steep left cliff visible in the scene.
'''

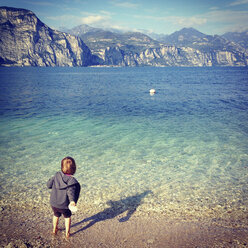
[68,26,248,66]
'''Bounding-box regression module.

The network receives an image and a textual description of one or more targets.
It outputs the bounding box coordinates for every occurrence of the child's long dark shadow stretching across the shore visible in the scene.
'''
[72,190,152,235]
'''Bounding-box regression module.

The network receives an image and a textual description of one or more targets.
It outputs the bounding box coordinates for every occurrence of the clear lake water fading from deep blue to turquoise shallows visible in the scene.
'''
[0,67,248,218]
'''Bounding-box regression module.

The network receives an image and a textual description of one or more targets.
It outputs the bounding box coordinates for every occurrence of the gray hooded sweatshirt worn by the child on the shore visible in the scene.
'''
[47,171,81,209]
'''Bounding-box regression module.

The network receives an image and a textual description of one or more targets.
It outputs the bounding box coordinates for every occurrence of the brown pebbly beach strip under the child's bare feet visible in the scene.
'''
[0,200,248,248]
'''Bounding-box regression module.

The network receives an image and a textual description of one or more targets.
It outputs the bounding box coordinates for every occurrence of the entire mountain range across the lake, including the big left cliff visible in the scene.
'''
[0,7,248,66]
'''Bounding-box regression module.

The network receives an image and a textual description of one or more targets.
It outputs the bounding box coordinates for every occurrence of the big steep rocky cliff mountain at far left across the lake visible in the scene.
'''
[0,7,94,66]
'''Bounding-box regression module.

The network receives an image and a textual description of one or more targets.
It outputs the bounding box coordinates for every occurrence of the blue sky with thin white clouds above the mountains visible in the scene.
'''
[0,0,248,35]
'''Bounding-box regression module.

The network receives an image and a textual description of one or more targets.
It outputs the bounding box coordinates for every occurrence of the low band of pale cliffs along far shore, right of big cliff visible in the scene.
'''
[86,45,248,67]
